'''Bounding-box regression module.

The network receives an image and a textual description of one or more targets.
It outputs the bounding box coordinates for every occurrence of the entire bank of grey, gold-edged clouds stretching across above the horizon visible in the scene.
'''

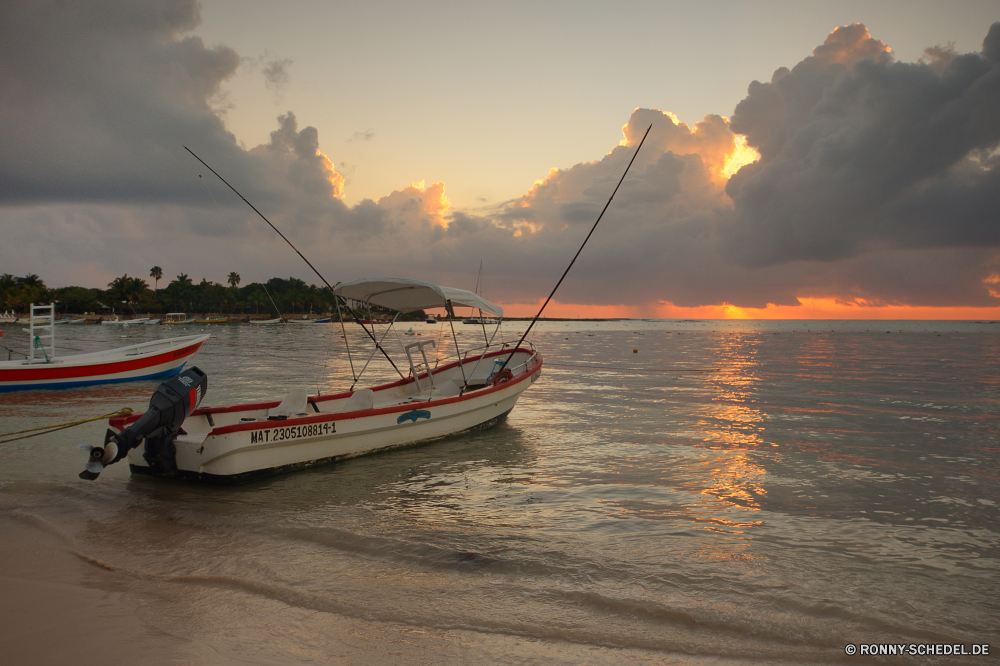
[0,0,1000,307]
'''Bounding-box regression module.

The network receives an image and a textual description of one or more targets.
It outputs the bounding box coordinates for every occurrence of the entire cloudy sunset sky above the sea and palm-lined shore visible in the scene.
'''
[0,0,1000,319]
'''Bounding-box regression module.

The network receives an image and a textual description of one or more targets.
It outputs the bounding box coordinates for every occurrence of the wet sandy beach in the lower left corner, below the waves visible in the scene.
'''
[0,510,720,666]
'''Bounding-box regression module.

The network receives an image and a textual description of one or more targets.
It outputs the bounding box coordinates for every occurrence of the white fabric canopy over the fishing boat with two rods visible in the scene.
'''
[334,278,503,317]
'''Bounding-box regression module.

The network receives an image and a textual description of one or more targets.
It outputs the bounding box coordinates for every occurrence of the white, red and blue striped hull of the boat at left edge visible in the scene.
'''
[0,335,209,392]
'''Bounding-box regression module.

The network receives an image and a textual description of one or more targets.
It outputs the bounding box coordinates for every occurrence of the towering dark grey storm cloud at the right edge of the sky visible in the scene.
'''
[723,24,1000,266]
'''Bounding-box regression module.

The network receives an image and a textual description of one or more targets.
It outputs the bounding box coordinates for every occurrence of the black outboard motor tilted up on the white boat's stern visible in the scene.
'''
[80,366,208,481]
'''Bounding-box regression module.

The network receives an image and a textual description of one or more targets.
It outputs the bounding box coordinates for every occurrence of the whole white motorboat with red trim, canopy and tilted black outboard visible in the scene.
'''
[95,279,542,483]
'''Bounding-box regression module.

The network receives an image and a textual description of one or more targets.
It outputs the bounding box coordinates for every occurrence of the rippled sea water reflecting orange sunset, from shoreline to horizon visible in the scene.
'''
[0,322,1000,661]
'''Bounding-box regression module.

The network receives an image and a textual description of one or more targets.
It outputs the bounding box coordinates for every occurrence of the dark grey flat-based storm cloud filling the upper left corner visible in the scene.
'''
[0,0,344,220]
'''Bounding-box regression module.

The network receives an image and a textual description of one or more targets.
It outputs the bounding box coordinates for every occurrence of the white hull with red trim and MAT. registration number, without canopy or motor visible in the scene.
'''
[123,354,542,483]
